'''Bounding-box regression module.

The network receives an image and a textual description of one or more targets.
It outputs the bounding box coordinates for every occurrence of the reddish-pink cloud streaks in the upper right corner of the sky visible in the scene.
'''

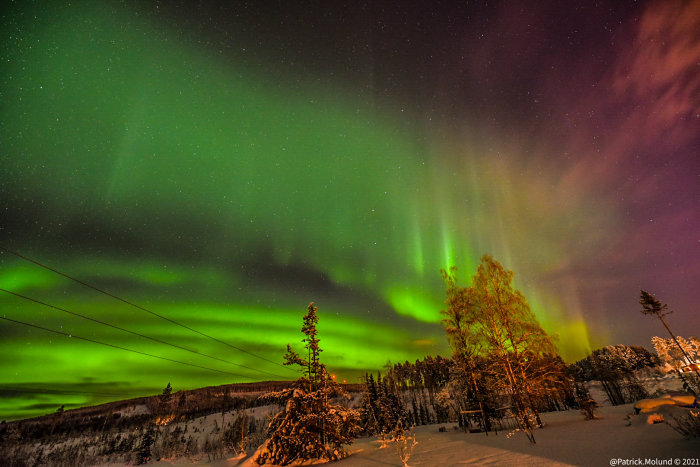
[610,1,700,150]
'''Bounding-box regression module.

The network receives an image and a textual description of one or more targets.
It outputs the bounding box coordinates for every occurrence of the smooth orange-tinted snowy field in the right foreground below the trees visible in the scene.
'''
[198,404,700,467]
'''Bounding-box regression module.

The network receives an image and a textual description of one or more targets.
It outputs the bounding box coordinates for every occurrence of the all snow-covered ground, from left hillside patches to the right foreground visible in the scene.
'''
[5,370,700,467]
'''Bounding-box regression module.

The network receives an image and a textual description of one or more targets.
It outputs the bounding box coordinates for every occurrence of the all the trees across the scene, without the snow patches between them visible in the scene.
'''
[0,255,700,465]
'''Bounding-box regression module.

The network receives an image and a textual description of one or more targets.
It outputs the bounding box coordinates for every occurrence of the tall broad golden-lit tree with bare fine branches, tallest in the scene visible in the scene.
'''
[443,255,564,443]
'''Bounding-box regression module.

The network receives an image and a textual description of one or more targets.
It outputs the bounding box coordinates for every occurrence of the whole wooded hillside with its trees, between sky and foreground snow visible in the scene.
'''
[0,255,700,466]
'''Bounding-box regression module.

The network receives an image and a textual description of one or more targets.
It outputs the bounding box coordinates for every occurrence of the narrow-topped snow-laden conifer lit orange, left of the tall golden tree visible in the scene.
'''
[255,303,360,465]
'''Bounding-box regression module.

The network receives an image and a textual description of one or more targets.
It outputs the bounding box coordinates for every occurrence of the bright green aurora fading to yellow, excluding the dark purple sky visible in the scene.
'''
[6,2,700,419]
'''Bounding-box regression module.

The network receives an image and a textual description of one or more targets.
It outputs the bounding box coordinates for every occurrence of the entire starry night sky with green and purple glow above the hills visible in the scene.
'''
[0,0,700,419]
